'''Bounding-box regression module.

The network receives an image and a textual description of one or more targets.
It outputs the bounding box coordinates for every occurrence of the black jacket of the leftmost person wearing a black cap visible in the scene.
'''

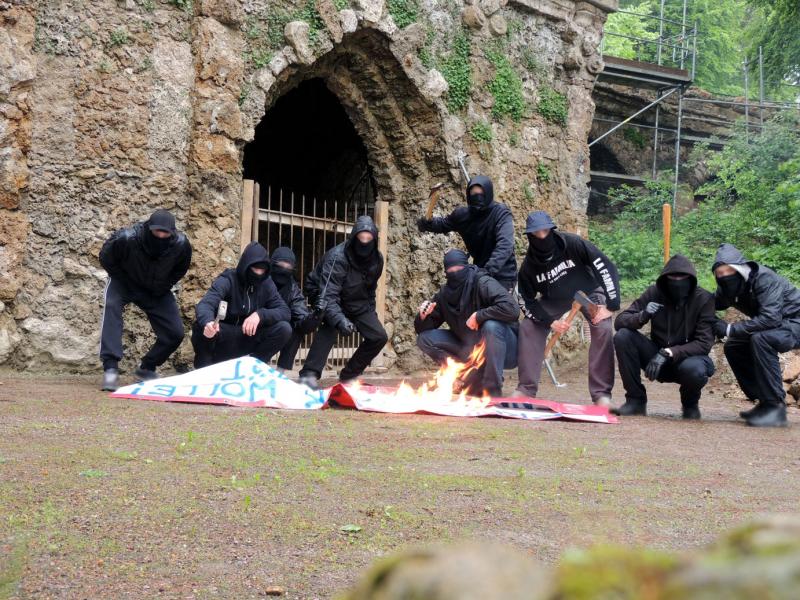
[100,223,192,296]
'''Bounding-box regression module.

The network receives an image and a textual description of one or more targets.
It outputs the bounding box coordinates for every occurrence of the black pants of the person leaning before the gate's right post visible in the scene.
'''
[300,310,389,380]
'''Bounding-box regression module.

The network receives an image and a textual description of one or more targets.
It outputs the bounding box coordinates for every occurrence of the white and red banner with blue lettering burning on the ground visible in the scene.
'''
[111,354,617,423]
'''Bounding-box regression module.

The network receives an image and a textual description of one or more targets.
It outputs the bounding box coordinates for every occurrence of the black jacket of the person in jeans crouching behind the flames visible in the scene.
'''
[414,265,519,346]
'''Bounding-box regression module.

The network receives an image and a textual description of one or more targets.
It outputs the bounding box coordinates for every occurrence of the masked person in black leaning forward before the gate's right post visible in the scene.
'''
[300,215,389,388]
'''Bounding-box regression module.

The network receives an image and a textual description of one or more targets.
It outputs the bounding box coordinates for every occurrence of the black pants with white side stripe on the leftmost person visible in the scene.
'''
[100,277,183,371]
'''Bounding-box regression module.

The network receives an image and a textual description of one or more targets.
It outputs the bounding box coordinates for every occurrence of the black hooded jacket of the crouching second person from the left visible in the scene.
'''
[195,242,292,327]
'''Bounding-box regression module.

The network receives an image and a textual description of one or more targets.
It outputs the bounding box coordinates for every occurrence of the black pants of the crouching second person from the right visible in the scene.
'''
[614,329,714,407]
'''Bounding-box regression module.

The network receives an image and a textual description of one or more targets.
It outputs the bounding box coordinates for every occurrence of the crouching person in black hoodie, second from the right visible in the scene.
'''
[612,254,715,419]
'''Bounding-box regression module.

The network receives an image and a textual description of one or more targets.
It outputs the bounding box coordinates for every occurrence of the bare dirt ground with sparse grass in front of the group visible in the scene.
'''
[0,368,800,598]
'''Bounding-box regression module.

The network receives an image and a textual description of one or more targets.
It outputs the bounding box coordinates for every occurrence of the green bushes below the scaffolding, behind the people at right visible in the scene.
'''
[590,113,800,296]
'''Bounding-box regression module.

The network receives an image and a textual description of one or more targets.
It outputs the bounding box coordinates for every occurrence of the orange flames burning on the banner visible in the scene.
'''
[396,340,490,407]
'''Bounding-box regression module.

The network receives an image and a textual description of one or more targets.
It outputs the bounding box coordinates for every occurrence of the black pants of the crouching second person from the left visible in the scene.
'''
[192,321,292,369]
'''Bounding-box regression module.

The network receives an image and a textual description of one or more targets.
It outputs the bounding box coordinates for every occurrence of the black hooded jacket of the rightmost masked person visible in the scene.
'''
[714,244,800,337]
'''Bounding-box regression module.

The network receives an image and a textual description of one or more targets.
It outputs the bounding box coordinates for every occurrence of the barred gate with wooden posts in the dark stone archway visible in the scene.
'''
[241,179,388,369]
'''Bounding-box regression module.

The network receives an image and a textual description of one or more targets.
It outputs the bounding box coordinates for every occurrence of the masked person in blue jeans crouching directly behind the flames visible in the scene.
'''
[414,249,519,397]
